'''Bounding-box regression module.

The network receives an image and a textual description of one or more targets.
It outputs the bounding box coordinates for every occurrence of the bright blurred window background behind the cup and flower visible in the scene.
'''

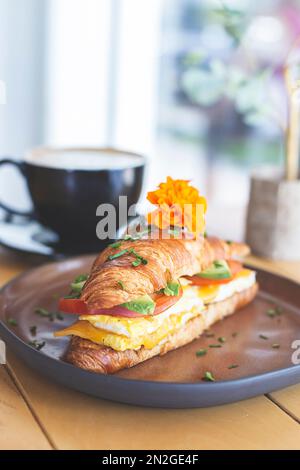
[0,0,300,239]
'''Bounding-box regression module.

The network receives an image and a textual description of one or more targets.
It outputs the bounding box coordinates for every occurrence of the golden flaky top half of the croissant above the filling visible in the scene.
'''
[81,237,249,309]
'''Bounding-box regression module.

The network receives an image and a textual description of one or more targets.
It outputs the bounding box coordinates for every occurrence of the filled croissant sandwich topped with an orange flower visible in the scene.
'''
[55,178,258,374]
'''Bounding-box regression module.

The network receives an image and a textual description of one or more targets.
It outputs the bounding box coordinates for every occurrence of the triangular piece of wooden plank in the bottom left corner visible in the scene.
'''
[0,365,51,450]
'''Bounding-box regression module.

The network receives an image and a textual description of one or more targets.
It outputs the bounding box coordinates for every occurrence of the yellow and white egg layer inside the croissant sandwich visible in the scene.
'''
[56,269,255,351]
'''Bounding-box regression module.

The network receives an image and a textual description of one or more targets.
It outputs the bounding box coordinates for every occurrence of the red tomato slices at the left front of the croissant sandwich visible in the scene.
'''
[59,288,182,318]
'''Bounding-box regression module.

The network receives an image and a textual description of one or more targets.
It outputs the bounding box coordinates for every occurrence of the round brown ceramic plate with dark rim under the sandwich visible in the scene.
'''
[0,256,300,408]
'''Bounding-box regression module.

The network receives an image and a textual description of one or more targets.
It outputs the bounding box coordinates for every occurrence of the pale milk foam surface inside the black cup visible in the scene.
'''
[25,150,143,171]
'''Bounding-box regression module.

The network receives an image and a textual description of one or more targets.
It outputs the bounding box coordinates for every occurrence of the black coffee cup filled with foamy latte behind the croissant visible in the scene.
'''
[0,147,145,251]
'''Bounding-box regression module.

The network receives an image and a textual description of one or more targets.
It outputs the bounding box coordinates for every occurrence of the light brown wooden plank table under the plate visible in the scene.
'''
[0,250,300,450]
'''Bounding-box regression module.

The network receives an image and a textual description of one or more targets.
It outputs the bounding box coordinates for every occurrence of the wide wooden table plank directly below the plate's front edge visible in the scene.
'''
[5,356,300,449]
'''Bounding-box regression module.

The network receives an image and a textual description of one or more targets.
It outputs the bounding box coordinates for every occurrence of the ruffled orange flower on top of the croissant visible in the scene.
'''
[147,176,207,237]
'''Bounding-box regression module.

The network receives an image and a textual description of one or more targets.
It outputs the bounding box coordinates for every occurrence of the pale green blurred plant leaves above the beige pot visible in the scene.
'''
[181,5,276,130]
